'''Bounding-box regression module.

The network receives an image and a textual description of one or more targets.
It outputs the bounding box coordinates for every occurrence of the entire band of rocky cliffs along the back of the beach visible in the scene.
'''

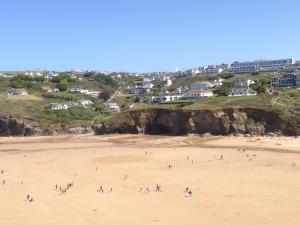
[0,108,300,136]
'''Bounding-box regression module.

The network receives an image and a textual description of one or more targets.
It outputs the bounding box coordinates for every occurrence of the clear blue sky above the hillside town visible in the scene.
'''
[0,0,300,72]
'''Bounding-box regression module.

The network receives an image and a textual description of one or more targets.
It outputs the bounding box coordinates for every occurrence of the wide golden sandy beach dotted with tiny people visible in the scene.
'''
[0,135,300,225]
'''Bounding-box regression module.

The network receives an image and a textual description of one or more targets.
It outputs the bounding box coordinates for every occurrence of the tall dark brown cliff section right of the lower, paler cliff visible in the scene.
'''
[94,108,300,135]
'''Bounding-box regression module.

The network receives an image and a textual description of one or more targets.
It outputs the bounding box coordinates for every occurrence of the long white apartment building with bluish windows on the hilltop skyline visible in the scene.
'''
[231,59,295,73]
